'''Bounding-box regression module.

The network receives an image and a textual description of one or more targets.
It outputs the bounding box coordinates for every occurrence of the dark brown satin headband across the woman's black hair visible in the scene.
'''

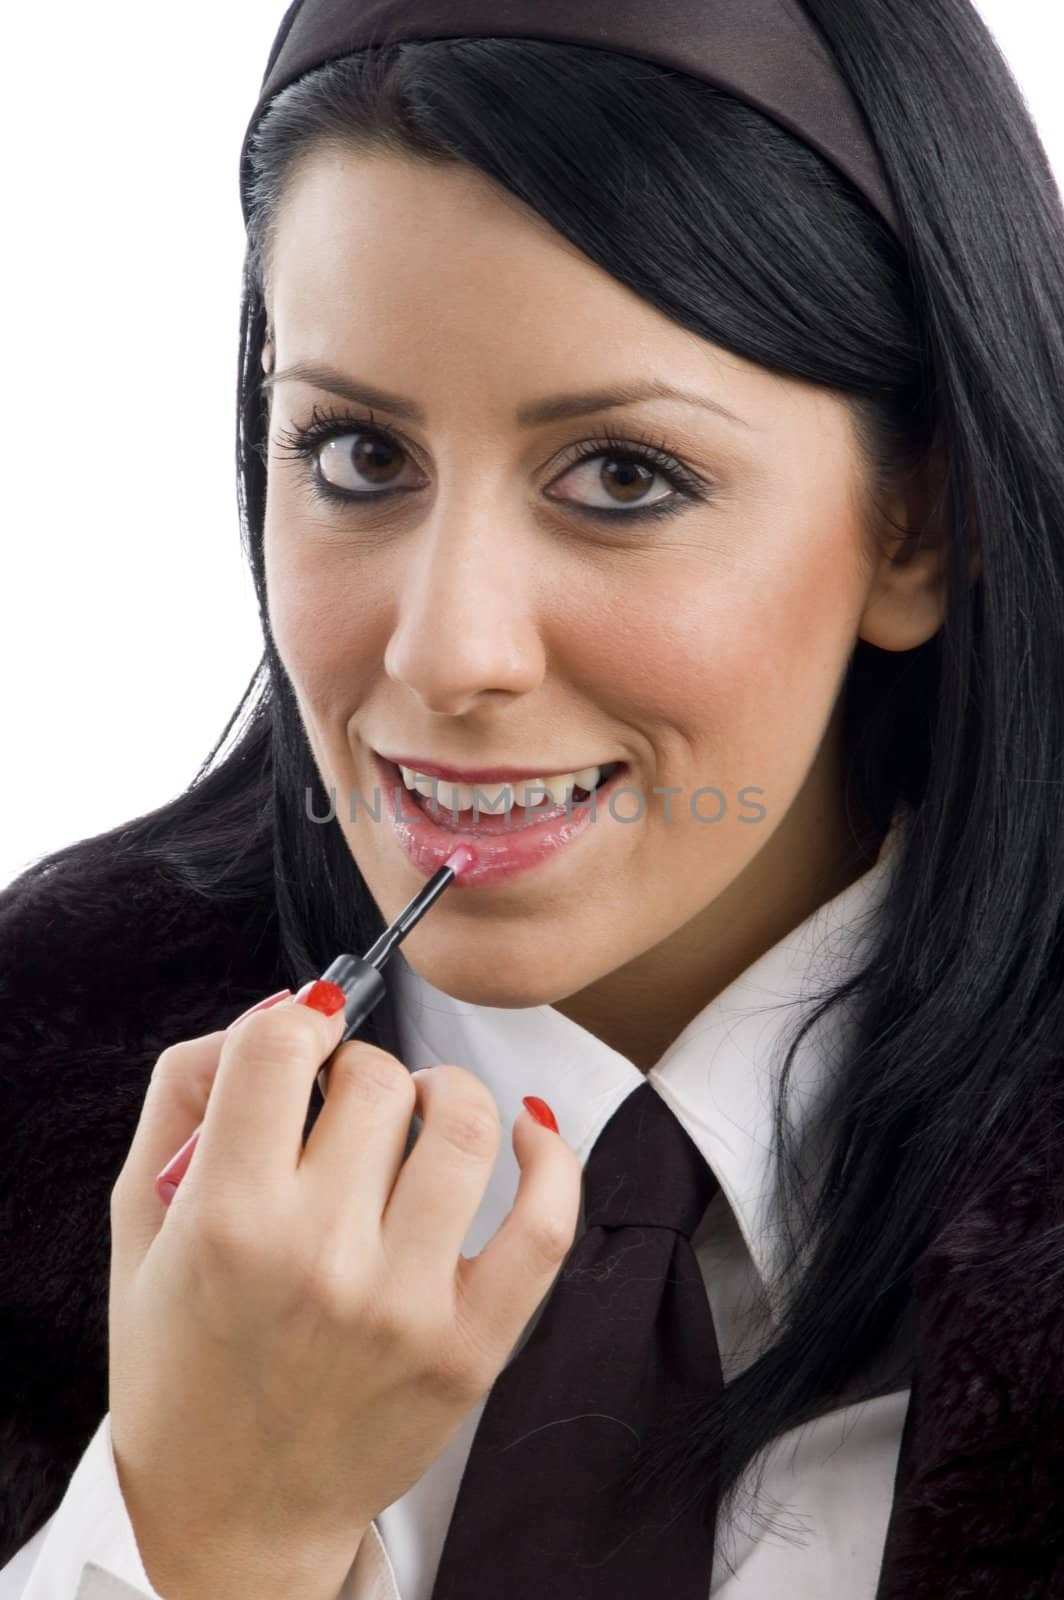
[240,0,898,232]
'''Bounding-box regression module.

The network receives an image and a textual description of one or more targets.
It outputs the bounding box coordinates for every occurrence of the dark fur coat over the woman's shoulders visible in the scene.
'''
[0,845,1064,1600]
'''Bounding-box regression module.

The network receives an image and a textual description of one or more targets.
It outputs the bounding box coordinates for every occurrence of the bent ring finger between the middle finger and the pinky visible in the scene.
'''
[381,1066,499,1285]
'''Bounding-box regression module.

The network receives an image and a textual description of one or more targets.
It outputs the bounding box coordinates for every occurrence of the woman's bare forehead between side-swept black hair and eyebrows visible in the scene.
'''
[267,149,830,451]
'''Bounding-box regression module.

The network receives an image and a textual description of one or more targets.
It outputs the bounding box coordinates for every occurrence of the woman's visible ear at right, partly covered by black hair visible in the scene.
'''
[858,434,982,650]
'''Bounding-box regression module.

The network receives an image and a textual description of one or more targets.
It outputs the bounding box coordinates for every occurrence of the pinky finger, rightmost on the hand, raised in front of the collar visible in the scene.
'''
[458,1110,584,1360]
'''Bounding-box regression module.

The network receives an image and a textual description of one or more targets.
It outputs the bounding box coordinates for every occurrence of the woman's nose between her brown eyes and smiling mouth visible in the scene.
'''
[384,504,546,715]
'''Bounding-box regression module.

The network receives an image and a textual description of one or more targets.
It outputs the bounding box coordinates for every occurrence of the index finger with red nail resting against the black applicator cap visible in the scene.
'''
[192,979,346,1197]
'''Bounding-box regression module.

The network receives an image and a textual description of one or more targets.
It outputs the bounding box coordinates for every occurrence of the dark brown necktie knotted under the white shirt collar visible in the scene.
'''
[432,1082,723,1600]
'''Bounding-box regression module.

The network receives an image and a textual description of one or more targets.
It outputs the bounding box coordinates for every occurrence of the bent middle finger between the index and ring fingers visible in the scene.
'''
[299,1038,418,1238]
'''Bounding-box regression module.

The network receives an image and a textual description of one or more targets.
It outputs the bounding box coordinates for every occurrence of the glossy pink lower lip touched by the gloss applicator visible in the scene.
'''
[371,750,627,893]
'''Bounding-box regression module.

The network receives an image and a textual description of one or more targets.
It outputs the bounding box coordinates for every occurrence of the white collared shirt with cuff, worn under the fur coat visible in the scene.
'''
[0,822,910,1600]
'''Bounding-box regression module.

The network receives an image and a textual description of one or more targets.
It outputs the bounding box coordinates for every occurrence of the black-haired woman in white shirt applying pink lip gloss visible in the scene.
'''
[0,0,1064,1600]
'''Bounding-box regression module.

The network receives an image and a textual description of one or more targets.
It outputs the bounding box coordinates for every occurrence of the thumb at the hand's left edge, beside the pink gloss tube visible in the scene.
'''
[112,989,291,1253]
